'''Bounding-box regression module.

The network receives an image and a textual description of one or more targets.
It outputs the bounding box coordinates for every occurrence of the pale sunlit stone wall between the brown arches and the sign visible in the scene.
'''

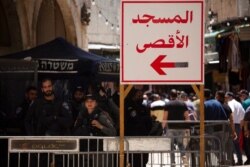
[88,0,120,46]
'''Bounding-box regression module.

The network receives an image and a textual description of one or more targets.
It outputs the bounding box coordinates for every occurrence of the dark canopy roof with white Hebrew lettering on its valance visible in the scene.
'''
[0,38,120,80]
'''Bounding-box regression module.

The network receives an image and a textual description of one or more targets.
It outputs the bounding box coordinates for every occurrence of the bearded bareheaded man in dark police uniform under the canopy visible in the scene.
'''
[25,79,73,136]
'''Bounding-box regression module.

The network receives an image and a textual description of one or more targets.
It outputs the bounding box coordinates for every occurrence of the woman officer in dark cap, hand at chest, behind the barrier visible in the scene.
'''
[74,94,116,167]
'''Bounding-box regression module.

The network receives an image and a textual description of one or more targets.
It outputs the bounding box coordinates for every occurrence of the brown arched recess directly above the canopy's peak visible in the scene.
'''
[32,0,77,46]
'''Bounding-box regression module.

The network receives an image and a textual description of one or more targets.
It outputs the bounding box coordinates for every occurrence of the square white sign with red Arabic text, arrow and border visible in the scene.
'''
[120,0,204,84]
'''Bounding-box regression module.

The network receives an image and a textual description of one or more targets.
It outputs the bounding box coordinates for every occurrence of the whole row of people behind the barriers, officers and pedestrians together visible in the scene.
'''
[1,79,250,166]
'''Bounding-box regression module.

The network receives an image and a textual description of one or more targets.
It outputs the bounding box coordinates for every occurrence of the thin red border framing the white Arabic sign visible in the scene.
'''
[120,0,204,84]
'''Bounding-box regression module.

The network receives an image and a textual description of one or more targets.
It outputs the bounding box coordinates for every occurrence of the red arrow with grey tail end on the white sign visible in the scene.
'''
[151,55,188,75]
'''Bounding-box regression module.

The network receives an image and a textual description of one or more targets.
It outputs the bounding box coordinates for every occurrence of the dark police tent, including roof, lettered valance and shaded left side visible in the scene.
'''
[0,38,119,131]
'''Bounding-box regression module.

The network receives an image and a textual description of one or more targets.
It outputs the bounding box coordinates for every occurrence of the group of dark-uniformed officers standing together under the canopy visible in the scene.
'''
[16,79,118,136]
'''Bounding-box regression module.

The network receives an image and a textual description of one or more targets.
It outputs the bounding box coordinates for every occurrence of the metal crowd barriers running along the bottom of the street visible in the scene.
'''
[0,122,233,167]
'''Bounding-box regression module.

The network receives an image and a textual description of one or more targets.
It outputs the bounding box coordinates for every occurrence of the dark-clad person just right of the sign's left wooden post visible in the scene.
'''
[124,89,152,167]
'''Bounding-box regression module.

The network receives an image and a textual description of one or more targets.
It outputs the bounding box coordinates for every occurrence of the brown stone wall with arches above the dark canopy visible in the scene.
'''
[0,0,90,55]
